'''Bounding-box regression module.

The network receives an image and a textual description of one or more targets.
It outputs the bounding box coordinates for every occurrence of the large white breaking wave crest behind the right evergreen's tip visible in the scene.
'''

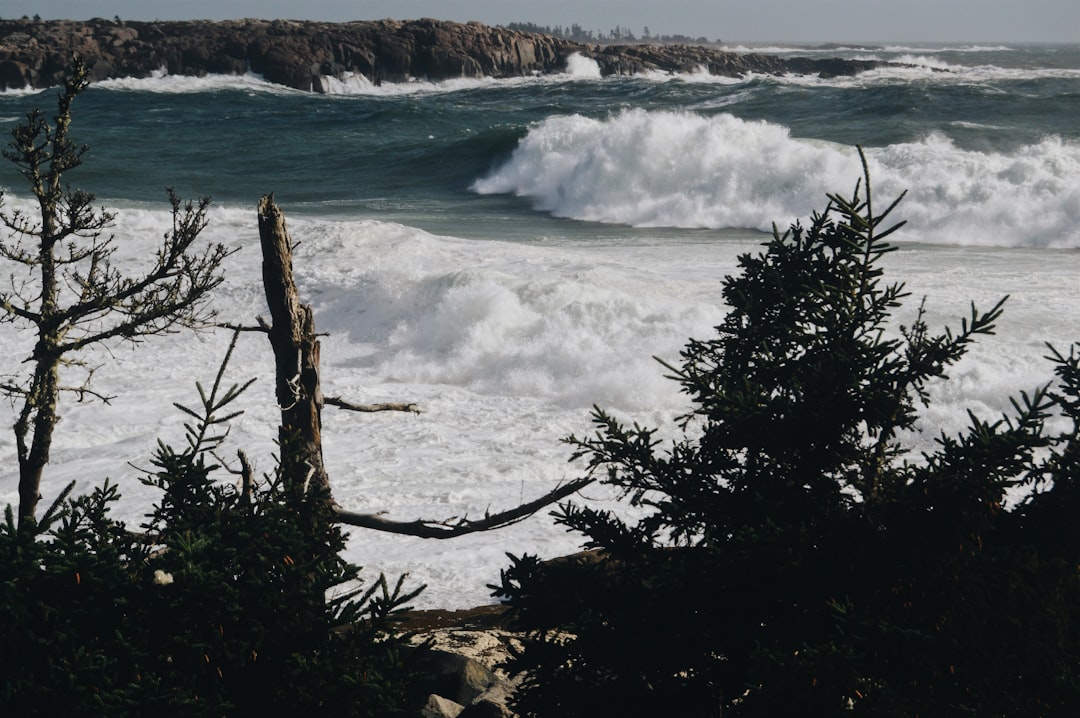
[473,109,1080,247]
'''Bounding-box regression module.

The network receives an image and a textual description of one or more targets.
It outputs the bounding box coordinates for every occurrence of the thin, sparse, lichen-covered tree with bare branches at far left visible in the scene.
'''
[0,59,230,524]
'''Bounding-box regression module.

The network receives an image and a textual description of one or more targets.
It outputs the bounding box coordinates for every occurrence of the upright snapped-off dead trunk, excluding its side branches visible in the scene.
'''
[258,194,330,501]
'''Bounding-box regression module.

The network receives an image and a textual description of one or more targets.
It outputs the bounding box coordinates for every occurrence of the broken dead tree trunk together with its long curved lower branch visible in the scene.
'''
[254,195,594,539]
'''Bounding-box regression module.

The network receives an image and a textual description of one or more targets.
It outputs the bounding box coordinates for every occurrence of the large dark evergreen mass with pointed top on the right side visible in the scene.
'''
[496,152,1080,717]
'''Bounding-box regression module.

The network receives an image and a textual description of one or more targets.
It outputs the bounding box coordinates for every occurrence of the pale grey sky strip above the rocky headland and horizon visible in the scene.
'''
[0,0,1080,42]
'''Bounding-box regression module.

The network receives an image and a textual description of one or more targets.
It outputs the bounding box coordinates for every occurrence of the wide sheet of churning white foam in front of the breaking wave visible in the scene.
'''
[0,168,1080,608]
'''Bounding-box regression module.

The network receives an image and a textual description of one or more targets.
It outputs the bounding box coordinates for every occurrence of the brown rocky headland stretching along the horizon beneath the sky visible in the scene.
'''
[0,18,882,92]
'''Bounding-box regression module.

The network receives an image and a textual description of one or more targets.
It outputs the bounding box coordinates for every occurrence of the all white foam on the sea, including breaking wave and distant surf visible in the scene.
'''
[0,48,1080,608]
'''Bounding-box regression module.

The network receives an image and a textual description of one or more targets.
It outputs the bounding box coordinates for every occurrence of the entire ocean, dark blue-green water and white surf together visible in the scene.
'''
[0,44,1080,608]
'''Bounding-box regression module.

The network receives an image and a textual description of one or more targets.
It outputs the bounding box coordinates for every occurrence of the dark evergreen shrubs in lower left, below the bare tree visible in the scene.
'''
[0,332,419,717]
